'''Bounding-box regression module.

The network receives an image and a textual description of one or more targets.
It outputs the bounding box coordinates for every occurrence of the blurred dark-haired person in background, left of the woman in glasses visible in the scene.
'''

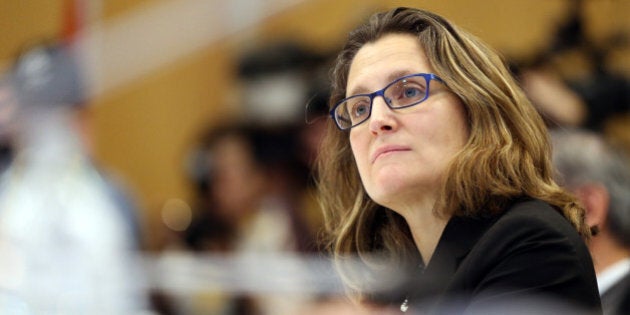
[186,124,304,252]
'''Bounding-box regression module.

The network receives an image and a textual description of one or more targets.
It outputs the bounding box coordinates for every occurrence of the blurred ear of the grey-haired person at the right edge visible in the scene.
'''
[574,183,610,230]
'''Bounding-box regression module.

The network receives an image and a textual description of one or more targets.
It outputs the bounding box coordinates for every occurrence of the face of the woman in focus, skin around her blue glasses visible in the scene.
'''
[346,34,469,212]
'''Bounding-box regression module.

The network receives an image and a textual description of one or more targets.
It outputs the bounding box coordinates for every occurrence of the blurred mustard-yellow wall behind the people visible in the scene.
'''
[0,0,630,244]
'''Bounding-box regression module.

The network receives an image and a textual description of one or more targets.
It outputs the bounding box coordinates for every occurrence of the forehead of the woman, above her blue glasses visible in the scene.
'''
[347,34,433,94]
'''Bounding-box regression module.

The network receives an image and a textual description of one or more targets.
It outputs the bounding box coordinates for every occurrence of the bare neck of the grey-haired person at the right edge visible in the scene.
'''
[589,231,630,274]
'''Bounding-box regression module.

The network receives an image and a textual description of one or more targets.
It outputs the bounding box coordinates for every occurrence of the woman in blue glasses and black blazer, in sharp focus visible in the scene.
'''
[318,8,601,314]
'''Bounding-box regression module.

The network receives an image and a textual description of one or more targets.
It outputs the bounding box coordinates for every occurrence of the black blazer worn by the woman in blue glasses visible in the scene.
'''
[392,199,601,314]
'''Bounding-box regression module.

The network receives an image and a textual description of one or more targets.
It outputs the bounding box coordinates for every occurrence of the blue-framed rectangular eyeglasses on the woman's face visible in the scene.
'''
[330,73,444,130]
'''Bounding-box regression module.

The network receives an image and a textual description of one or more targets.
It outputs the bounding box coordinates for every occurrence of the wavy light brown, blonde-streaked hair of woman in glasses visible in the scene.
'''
[317,8,591,302]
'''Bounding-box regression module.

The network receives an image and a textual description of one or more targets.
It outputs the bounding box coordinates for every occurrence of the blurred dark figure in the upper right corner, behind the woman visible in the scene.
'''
[520,0,630,131]
